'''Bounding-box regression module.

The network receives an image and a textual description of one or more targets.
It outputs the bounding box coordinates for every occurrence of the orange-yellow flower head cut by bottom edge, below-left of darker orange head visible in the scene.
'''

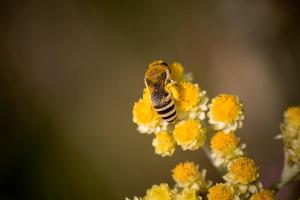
[207,183,234,200]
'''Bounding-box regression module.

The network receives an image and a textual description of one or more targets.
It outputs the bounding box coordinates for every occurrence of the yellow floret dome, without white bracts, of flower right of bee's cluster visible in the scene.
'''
[210,94,242,123]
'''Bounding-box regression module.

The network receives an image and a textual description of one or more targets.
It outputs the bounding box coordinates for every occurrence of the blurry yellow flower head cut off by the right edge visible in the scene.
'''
[281,106,300,166]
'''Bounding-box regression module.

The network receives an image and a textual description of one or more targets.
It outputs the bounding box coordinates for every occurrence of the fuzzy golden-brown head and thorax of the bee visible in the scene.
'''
[145,60,170,90]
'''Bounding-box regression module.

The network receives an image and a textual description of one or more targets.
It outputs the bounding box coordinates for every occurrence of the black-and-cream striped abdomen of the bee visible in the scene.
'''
[153,93,177,122]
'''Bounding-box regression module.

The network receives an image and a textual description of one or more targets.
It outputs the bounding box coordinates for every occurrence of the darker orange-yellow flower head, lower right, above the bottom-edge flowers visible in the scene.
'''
[225,157,259,184]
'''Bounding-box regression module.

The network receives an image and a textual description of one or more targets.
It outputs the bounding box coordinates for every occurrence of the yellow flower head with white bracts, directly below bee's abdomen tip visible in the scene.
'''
[173,120,206,150]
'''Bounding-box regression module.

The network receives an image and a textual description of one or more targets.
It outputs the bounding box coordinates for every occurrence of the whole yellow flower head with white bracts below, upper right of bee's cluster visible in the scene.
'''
[207,94,244,133]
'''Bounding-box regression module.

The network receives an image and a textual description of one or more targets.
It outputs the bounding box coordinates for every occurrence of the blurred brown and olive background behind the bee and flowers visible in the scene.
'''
[0,0,300,200]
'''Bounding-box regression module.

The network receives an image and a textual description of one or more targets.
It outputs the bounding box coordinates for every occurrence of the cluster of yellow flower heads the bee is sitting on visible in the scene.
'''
[133,61,208,156]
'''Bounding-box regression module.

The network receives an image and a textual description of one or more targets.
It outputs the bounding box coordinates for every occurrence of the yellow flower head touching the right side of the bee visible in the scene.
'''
[167,82,200,111]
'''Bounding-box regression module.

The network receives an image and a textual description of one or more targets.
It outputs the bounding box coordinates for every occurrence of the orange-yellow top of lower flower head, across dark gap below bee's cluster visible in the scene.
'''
[172,162,200,185]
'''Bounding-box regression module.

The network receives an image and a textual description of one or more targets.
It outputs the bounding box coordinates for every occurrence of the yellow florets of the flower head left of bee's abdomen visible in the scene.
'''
[133,99,159,125]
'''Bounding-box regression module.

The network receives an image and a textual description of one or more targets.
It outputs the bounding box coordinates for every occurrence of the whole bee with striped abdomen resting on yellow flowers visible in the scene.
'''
[145,60,177,122]
